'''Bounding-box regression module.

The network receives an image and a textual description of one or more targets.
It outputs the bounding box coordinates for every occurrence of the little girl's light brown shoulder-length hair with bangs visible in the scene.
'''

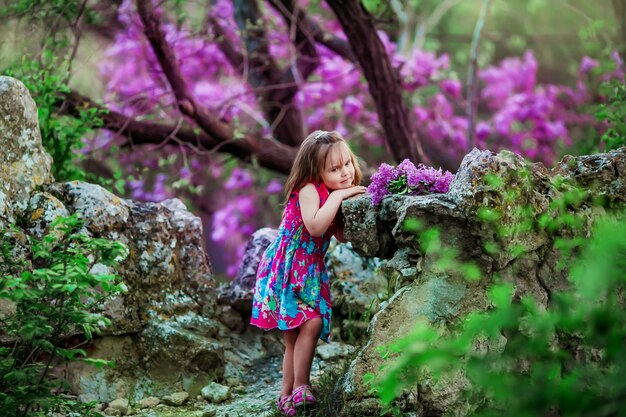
[285,130,361,200]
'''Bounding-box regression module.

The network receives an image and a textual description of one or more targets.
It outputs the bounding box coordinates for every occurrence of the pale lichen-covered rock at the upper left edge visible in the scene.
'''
[0,76,53,227]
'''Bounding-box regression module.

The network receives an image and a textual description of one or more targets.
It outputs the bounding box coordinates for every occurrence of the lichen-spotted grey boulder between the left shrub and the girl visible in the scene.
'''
[46,181,215,324]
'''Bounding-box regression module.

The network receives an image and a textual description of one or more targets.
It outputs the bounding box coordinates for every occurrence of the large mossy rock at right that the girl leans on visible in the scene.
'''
[341,148,626,415]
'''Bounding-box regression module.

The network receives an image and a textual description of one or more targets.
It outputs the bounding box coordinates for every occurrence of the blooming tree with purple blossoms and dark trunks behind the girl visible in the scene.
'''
[4,0,624,272]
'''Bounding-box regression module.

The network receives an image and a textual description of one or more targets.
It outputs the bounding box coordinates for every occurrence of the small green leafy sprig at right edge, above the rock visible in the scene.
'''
[596,80,626,150]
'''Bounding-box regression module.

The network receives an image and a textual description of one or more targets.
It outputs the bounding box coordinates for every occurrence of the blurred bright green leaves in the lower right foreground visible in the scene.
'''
[379,213,626,416]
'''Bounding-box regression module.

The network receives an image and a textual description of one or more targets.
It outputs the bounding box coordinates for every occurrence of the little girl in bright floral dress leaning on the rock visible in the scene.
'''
[250,130,365,416]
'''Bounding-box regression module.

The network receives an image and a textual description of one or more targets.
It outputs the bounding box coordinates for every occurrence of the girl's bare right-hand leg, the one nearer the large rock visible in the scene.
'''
[292,317,322,388]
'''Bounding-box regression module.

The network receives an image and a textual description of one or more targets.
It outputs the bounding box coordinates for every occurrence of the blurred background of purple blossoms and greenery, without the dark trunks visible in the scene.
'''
[0,0,626,279]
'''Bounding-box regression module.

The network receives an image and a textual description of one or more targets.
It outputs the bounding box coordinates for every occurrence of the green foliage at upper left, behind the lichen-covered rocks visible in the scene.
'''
[0,0,128,193]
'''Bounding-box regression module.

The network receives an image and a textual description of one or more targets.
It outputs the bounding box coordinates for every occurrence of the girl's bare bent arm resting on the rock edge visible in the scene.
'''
[299,183,365,237]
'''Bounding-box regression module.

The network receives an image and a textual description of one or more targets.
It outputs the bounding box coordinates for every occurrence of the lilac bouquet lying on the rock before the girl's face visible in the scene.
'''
[367,159,454,206]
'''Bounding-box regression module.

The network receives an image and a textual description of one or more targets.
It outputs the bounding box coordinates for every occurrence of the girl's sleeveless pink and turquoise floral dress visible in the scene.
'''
[250,182,336,342]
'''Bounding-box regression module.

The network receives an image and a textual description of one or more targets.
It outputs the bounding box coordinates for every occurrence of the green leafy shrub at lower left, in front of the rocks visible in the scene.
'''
[0,215,128,416]
